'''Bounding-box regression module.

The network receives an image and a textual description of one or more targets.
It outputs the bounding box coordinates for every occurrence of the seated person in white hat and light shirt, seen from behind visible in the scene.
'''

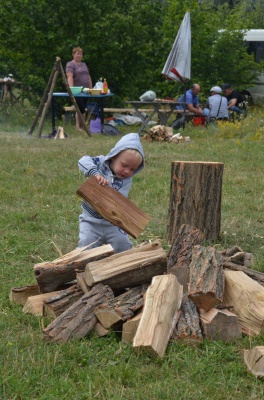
[204,86,228,121]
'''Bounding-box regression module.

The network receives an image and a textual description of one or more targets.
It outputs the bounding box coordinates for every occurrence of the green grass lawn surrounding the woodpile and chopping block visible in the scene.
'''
[0,104,264,400]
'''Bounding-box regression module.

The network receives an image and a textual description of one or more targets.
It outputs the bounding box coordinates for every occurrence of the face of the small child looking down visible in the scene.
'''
[110,150,142,179]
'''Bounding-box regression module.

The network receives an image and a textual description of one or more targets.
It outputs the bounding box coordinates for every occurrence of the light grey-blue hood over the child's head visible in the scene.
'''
[105,133,145,175]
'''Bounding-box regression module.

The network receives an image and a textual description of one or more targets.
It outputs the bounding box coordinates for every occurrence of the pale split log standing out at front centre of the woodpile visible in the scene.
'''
[133,274,183,357]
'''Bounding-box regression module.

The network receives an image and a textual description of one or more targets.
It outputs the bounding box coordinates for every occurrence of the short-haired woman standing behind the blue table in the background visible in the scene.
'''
[66,47,93,131]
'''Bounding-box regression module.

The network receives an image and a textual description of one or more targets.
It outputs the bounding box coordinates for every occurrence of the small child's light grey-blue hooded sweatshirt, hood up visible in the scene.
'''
[78,133,145,218]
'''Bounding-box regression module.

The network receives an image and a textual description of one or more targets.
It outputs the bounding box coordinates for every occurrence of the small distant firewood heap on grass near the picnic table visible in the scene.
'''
[143,125,190,143]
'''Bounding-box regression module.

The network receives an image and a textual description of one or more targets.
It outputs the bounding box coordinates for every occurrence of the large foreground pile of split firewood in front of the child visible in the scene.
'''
[10,224,264,372]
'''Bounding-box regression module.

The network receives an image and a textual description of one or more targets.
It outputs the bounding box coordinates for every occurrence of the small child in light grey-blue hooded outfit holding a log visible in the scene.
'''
[78,133,144,253]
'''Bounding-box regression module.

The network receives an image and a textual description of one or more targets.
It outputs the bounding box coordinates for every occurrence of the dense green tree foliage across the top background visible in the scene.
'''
[0,0,264,104]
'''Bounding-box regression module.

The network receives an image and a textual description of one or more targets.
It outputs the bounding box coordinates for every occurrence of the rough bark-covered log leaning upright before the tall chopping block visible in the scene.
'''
[167,224,204,292]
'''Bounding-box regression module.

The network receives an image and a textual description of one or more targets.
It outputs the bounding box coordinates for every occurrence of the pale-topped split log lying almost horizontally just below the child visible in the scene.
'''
[85,241,167,290]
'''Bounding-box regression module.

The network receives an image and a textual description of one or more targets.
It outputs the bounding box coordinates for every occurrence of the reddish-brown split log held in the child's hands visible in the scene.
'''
[76,176,151,238]
